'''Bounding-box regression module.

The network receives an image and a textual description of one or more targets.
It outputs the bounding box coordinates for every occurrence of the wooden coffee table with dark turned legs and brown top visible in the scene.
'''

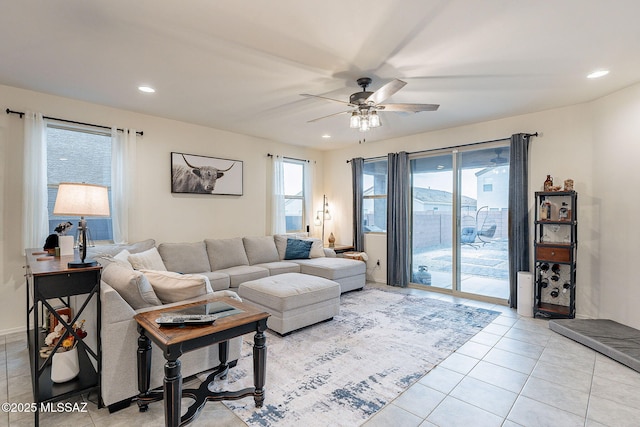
[134,297,269,427]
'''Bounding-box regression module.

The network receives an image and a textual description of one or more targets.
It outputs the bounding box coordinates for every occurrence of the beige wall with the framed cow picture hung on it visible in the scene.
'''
[0,86,323,334]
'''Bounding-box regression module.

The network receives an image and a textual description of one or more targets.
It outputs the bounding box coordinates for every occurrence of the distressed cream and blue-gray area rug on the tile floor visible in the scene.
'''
[216,289,499,427]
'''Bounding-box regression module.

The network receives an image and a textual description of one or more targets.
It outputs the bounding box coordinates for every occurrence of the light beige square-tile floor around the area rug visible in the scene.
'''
[0,284,640,427]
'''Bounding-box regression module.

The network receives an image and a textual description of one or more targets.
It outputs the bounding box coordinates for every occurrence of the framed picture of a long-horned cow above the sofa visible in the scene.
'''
[171,152,243,196]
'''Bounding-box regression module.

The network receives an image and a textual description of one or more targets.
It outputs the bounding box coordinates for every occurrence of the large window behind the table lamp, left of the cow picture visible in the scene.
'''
[47,124,113,241]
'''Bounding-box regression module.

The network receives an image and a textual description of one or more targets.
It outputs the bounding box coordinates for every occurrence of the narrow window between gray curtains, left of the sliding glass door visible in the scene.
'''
[362,159,387,233]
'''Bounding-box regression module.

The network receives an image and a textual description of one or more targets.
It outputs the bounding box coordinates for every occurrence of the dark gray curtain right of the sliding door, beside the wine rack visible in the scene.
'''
[509,133,530,308]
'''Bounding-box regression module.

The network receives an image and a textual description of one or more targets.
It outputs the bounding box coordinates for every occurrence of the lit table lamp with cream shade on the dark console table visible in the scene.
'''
[53,182,109,268]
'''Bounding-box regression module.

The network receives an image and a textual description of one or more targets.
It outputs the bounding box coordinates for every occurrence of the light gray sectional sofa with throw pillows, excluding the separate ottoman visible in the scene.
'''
[89,235,366,408]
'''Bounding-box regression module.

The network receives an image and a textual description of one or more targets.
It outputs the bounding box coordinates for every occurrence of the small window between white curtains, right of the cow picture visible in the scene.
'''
[283,159,306,233]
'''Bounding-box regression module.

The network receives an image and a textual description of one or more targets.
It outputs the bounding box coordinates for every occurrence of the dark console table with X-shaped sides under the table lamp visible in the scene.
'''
[25,249,102,426]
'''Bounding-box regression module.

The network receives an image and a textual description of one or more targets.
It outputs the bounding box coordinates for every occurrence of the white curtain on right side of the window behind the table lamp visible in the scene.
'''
[111,128,136,243]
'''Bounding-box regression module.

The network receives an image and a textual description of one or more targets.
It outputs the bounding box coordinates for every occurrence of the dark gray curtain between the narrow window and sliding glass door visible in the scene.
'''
[387,151,410,288]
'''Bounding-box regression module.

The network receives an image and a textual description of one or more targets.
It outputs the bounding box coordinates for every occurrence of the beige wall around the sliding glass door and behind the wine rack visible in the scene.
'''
[325,85,640,328]
